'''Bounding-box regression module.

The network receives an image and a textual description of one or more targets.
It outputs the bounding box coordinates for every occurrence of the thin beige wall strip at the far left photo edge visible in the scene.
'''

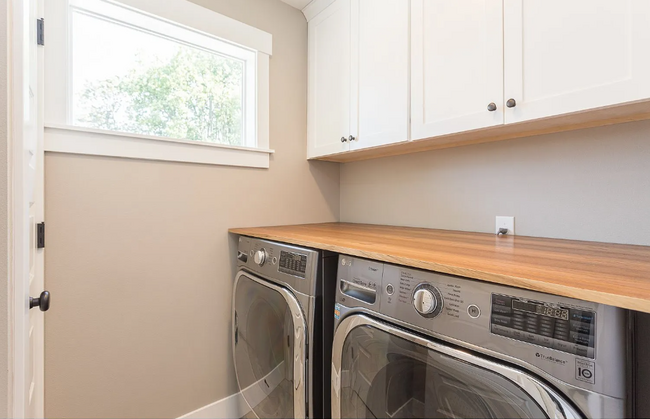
[0,0,9,416]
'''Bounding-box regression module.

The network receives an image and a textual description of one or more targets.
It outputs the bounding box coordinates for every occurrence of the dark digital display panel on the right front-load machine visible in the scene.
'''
[490,294,596,359]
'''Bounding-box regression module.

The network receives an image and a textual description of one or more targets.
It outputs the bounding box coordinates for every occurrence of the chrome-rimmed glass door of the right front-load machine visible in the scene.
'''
[332,315,571,418]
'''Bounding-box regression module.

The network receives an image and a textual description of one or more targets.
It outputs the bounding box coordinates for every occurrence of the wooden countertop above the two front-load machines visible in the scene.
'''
[230,223,650,313]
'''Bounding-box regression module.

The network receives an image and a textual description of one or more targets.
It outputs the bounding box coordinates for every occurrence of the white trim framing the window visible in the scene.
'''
[44,0,273,168]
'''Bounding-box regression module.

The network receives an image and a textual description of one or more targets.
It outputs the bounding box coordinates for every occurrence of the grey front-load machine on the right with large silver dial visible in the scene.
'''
[332,256,626,418]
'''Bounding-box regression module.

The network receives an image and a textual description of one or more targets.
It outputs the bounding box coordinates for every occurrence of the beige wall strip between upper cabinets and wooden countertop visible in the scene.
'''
[341,121,650,245]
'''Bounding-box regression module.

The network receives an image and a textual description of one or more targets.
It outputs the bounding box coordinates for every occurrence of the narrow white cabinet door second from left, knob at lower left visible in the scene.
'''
[350,0,410,150]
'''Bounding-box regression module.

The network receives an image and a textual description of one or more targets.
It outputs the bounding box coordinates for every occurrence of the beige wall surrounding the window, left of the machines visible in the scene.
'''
[45,0,339,417]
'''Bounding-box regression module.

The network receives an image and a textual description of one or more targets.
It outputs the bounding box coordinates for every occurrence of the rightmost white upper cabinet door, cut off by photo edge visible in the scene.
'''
[504,0,650,123]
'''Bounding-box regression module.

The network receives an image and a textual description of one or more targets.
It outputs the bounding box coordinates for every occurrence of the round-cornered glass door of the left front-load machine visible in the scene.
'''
[233,273,306,418]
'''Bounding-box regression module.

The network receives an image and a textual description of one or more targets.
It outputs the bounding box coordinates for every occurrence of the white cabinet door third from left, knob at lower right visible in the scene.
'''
[411,0,502,140]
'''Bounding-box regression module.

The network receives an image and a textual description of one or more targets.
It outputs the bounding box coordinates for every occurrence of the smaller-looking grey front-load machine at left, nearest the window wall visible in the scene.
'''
[232,237,337,418]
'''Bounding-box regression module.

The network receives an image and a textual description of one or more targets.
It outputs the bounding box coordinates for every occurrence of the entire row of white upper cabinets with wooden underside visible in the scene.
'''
[305,0,650,162]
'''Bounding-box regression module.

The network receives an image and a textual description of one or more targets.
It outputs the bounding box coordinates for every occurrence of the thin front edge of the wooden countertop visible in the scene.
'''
[229,228,650,313]
